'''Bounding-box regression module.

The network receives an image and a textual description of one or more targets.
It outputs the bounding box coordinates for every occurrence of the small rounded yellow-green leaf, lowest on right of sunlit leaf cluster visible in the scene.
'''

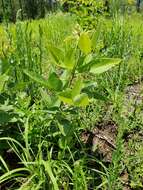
[74,93,89,106]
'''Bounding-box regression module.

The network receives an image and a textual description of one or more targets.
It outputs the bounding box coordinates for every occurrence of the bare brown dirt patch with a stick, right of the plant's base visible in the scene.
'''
[81,122,117,162]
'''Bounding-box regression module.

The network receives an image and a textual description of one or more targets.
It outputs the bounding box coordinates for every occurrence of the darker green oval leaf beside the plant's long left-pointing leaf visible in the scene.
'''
[47,72,63,91]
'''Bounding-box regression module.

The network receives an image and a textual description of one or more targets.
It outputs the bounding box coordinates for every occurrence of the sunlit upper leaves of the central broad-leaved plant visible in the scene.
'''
[24,32,121,106]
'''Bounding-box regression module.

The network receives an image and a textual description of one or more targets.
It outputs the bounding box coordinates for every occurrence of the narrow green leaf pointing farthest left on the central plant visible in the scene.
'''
[24,70,48,87]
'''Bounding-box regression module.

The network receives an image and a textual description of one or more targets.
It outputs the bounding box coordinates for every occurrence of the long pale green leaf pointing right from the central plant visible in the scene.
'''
[90,58,121,74]
